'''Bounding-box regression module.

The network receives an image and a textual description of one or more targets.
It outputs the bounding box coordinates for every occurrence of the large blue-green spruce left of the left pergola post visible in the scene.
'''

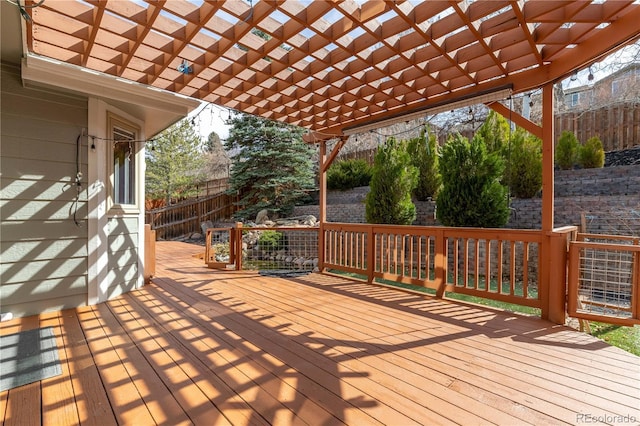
[225,114,315,219]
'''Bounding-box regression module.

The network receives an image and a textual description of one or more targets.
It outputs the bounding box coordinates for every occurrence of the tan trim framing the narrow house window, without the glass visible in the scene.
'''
[106,111,143,215]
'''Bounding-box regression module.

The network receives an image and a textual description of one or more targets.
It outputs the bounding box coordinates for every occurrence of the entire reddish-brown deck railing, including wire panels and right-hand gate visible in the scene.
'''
[205,223,640,325]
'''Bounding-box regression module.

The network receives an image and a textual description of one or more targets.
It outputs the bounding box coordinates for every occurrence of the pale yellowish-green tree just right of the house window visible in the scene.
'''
[145,119,205,204]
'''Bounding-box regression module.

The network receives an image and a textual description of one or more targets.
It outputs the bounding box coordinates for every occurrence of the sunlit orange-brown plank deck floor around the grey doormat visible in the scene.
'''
[0,242,640,425]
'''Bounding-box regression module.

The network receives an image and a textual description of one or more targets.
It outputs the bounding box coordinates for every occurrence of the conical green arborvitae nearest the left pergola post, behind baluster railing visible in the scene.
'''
[365,138,418,225]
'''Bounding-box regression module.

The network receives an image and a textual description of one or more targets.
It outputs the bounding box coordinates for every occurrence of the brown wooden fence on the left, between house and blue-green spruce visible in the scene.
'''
[145,194,237,239]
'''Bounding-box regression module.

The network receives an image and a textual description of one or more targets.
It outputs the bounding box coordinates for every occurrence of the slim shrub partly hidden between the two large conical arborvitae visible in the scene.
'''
[407,130,441,201]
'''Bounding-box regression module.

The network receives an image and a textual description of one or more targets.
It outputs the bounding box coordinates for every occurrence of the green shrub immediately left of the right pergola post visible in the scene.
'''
[503,129,542,198]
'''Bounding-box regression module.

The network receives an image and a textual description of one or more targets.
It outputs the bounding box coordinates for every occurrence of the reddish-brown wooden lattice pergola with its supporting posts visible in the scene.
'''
[19,0,640,322]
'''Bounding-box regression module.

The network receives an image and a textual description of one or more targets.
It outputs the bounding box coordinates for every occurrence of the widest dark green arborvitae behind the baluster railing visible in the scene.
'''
[436,134,510,228]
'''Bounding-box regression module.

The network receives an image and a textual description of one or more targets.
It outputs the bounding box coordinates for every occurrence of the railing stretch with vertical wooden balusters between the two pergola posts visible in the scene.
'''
[323,223,544,308]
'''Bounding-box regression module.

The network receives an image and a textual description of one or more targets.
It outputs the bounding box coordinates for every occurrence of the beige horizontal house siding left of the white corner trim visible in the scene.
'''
[0,64,88,316]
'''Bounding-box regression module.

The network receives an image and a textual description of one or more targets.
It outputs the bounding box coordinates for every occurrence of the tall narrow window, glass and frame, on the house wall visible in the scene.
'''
[109,116,138,206]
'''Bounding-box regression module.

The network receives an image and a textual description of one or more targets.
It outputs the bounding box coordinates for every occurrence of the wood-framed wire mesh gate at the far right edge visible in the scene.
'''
[568,234,640,326]
